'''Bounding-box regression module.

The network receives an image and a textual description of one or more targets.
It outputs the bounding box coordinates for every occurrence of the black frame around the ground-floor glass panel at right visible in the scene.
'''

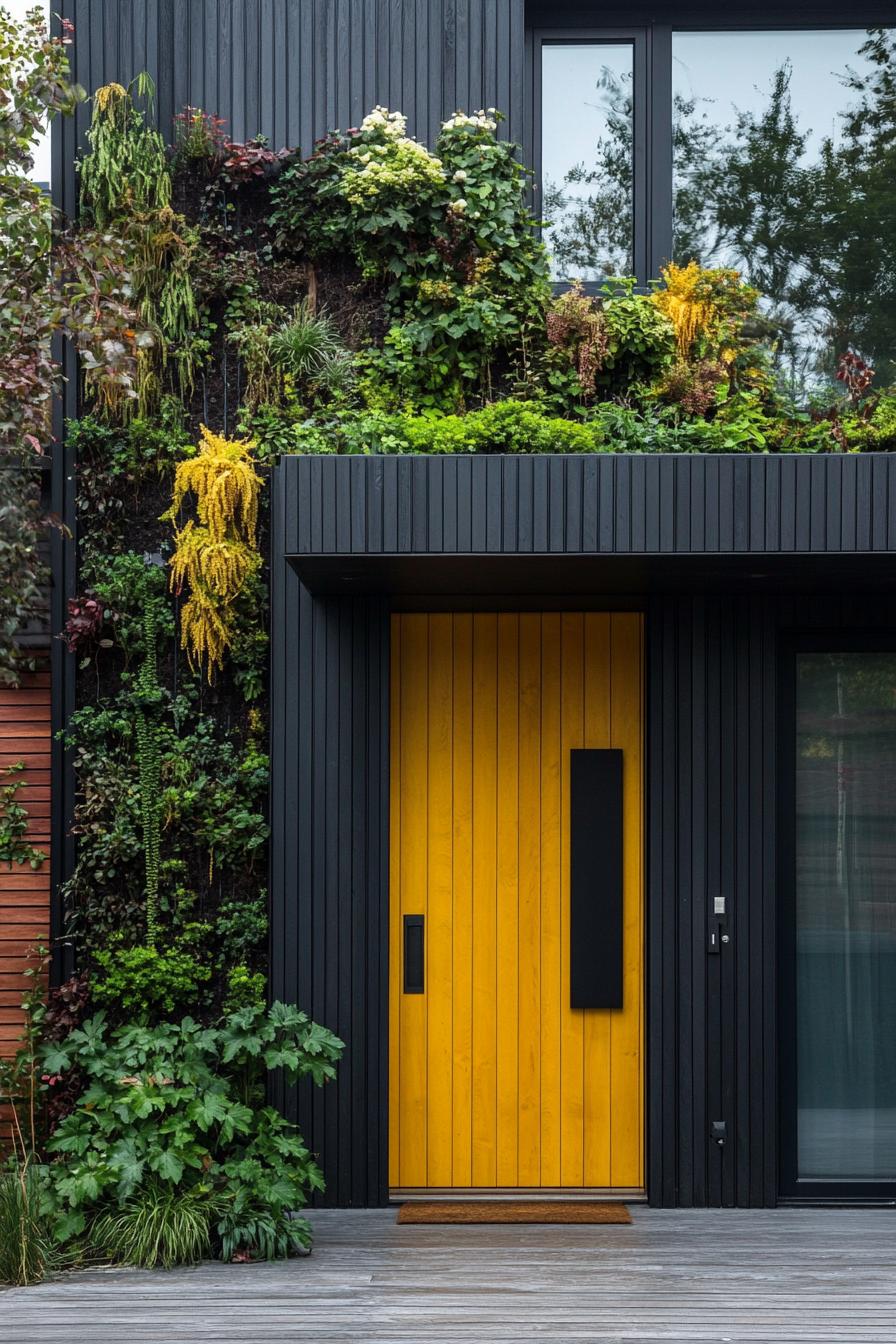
[776,626,896,1204]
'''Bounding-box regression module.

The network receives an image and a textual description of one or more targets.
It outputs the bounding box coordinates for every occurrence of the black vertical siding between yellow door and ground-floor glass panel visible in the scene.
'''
[646,594,896,1207]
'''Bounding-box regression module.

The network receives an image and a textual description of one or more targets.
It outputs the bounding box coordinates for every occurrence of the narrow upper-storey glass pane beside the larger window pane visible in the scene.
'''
[541,42,634,281]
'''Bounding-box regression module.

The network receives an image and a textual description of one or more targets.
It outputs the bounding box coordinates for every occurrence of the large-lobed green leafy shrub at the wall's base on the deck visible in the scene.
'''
[43,1004,343,1258]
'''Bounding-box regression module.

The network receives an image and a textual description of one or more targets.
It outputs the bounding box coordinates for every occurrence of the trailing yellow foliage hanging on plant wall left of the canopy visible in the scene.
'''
[163,425,262,681]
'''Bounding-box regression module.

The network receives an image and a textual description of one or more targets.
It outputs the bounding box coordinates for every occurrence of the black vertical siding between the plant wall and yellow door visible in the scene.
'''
[270,475,390,1207]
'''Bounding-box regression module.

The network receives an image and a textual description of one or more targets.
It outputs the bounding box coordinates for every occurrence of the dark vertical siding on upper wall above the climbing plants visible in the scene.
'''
[59,0,525,211]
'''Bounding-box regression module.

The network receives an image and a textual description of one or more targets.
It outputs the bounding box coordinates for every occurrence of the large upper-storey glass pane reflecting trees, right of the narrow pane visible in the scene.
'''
[673,30,896,402]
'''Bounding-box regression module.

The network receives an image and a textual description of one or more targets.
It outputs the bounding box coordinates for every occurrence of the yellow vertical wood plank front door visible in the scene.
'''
[390,612,645,1195]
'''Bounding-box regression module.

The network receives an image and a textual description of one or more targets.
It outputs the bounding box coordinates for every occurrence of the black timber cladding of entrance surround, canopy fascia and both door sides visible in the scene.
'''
[273,456,896,1207]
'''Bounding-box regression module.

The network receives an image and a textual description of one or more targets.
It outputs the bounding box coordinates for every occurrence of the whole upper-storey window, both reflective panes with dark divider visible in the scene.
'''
[540,28,896,398]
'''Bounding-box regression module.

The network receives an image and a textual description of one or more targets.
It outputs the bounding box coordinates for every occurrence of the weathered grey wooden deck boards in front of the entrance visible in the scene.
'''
[0,1207,896,1344]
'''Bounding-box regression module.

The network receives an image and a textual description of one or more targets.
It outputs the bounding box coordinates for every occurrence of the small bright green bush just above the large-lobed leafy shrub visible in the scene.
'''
[90,923,211,1021]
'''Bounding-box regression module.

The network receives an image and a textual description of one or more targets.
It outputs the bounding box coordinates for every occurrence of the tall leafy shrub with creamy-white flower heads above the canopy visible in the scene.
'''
[274,108,549,410]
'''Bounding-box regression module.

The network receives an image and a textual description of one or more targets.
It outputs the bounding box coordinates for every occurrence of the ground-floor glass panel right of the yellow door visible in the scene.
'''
[797,653,896,1181]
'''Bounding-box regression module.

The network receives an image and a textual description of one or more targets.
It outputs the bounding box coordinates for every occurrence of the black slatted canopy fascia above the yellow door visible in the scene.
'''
[282,453,896,556]
